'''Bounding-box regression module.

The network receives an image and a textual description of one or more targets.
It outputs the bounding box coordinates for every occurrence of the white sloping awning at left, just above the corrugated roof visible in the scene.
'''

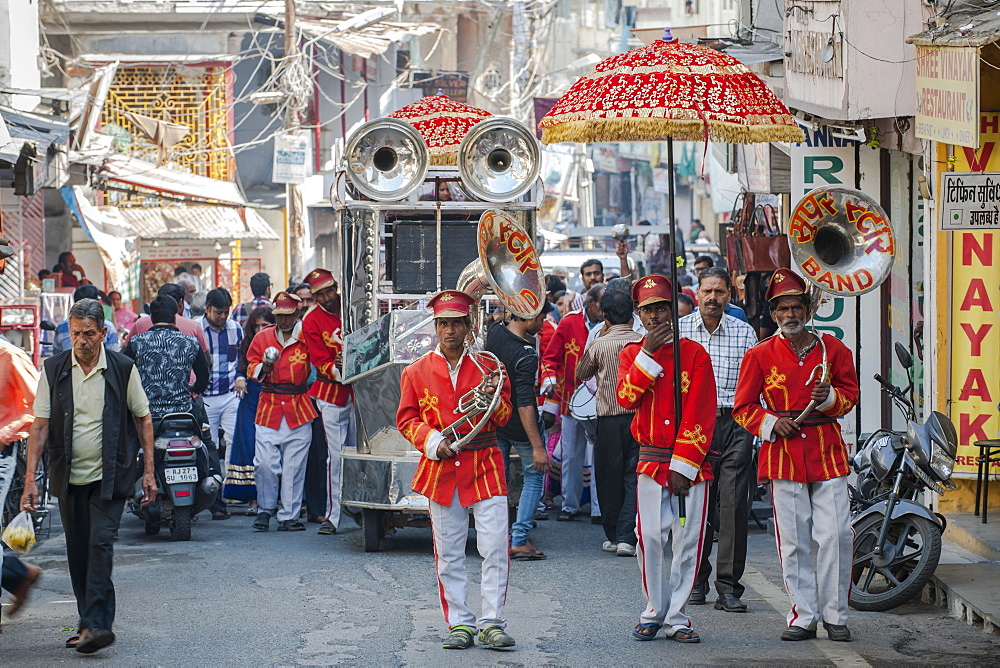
[98,154,247,206]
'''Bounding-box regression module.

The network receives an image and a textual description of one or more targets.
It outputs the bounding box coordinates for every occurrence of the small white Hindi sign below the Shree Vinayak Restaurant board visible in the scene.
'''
[941,172,1000,231]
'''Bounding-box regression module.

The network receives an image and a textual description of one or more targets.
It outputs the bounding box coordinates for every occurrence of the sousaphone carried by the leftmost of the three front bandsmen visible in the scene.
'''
[441,210,545,452]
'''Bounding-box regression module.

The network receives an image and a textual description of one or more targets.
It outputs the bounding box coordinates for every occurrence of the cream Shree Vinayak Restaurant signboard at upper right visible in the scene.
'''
[914,46,979,148]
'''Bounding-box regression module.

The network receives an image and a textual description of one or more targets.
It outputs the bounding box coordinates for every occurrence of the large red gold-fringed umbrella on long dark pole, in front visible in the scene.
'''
[538,29,805,501]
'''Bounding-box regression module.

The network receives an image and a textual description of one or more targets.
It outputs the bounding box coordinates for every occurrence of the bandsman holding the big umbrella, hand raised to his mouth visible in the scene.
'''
[618,274,716,643]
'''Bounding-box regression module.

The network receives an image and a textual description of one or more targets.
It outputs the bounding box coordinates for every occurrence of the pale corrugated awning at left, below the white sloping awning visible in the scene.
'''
[98,206,279,242]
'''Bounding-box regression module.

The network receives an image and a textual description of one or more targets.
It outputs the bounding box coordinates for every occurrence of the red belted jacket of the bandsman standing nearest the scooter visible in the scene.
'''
[247,323,319,429]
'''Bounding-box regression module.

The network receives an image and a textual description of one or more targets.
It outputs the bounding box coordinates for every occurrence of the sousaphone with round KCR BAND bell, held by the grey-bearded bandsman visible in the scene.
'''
[788,186,896,424]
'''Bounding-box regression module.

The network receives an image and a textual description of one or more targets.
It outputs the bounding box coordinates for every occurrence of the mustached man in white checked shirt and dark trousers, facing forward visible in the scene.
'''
[679,267,757,612]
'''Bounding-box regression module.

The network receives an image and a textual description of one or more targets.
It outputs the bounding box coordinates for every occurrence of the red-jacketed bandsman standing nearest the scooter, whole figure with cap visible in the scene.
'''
[247,292,319,531]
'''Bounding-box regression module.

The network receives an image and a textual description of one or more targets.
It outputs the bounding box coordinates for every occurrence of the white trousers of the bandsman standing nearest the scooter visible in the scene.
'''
[253,418,312,522]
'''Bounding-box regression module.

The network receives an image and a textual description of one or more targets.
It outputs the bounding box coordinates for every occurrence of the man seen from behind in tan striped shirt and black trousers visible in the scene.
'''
[576,287,642,557]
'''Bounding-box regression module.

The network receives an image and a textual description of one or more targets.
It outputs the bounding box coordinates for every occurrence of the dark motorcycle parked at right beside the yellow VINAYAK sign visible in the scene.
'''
[849,343,958,612]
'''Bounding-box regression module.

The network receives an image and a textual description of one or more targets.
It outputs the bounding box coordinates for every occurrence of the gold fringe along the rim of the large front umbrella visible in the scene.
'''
[542,118,805,144]
